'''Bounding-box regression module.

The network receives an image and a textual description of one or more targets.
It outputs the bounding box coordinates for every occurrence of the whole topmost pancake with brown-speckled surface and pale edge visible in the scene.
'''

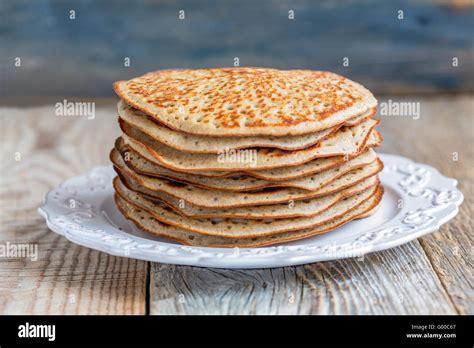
[114,68,377,137]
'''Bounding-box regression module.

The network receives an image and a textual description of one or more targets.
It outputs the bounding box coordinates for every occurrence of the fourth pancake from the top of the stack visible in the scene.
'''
[110,145,377,192]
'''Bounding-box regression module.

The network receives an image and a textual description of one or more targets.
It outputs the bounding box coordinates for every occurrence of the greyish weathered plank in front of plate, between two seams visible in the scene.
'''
[150,242,455,314]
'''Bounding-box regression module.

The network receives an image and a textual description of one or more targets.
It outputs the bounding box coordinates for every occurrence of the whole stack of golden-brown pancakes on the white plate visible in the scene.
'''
[110,68,383,247]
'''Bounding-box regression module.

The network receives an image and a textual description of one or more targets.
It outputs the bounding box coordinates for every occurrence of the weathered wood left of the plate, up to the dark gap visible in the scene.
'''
[0,104,148,314]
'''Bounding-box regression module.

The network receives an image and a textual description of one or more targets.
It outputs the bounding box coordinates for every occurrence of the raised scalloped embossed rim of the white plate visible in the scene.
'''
[38,153,464,269]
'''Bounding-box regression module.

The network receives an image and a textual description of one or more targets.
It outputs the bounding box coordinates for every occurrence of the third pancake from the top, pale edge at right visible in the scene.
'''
[122,119,378,172]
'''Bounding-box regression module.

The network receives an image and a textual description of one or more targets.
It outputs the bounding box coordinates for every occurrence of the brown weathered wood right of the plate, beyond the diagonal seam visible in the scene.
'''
[381,95,474,314]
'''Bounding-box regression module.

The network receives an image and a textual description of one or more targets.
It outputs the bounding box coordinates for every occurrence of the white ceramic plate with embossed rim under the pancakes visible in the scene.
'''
[38,154,463,268]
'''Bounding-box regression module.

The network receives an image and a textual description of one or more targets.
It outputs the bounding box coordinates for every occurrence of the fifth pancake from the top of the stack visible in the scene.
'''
[114,150,383,208]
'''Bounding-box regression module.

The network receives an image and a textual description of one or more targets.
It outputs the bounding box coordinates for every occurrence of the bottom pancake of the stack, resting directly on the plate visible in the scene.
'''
[115,186,383,248]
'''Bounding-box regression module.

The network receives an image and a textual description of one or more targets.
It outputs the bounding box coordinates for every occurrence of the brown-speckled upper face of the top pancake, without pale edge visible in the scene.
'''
[121,68,363,128]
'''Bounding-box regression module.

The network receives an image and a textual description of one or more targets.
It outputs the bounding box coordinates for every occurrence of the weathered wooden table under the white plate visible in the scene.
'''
[0,95,474,314]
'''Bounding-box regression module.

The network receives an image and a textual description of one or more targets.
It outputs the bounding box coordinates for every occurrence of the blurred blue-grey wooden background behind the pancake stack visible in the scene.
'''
[0,0,474,97]
